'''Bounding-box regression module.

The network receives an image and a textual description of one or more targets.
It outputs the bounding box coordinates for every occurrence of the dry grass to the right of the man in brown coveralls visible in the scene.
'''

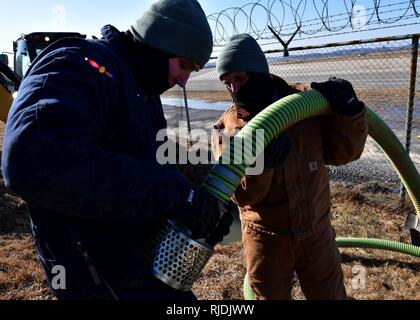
[332,183,420,300]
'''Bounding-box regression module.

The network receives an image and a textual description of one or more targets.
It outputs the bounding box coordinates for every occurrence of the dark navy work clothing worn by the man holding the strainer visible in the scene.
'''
[2,26,192,299]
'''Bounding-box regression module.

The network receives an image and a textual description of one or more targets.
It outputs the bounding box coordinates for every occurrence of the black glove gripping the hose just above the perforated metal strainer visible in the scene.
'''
[172,188,227,239]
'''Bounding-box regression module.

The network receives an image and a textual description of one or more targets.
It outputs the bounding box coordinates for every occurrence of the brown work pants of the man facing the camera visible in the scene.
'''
[242,221,347,300]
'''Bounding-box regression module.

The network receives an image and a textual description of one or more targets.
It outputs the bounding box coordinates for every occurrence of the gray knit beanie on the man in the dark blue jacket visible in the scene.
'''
[131,0,213,67]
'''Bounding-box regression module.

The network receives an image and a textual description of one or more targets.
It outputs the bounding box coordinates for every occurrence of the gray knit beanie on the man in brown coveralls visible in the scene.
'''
[217,33,270,78]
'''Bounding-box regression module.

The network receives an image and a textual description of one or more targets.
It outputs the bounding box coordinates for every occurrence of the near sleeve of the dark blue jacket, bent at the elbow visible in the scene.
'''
[2,49,192,222]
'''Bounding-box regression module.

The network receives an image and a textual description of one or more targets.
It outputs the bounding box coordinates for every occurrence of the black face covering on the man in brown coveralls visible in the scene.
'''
[231,72,276,117]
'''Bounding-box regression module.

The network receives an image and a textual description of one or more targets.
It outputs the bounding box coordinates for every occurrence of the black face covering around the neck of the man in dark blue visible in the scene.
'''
[121,31,175,95]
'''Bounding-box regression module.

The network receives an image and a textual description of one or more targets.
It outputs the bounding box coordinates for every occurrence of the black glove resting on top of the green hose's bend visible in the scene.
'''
[311,77,365,117]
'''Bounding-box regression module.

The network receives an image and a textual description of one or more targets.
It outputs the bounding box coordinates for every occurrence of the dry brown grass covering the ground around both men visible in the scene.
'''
[0,166,420,300]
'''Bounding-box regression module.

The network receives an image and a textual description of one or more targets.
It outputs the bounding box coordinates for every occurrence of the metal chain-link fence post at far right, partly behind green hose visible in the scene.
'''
[400,34,419,205]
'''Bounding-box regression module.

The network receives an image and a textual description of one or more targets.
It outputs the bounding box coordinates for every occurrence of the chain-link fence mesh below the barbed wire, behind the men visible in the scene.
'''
[162,35,420,200]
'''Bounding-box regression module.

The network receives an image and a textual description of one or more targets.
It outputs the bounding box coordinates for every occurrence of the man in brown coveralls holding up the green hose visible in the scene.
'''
[212,34,368,300]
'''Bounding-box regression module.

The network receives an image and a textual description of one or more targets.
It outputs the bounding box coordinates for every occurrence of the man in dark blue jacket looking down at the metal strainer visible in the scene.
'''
[2,0,231,300]
